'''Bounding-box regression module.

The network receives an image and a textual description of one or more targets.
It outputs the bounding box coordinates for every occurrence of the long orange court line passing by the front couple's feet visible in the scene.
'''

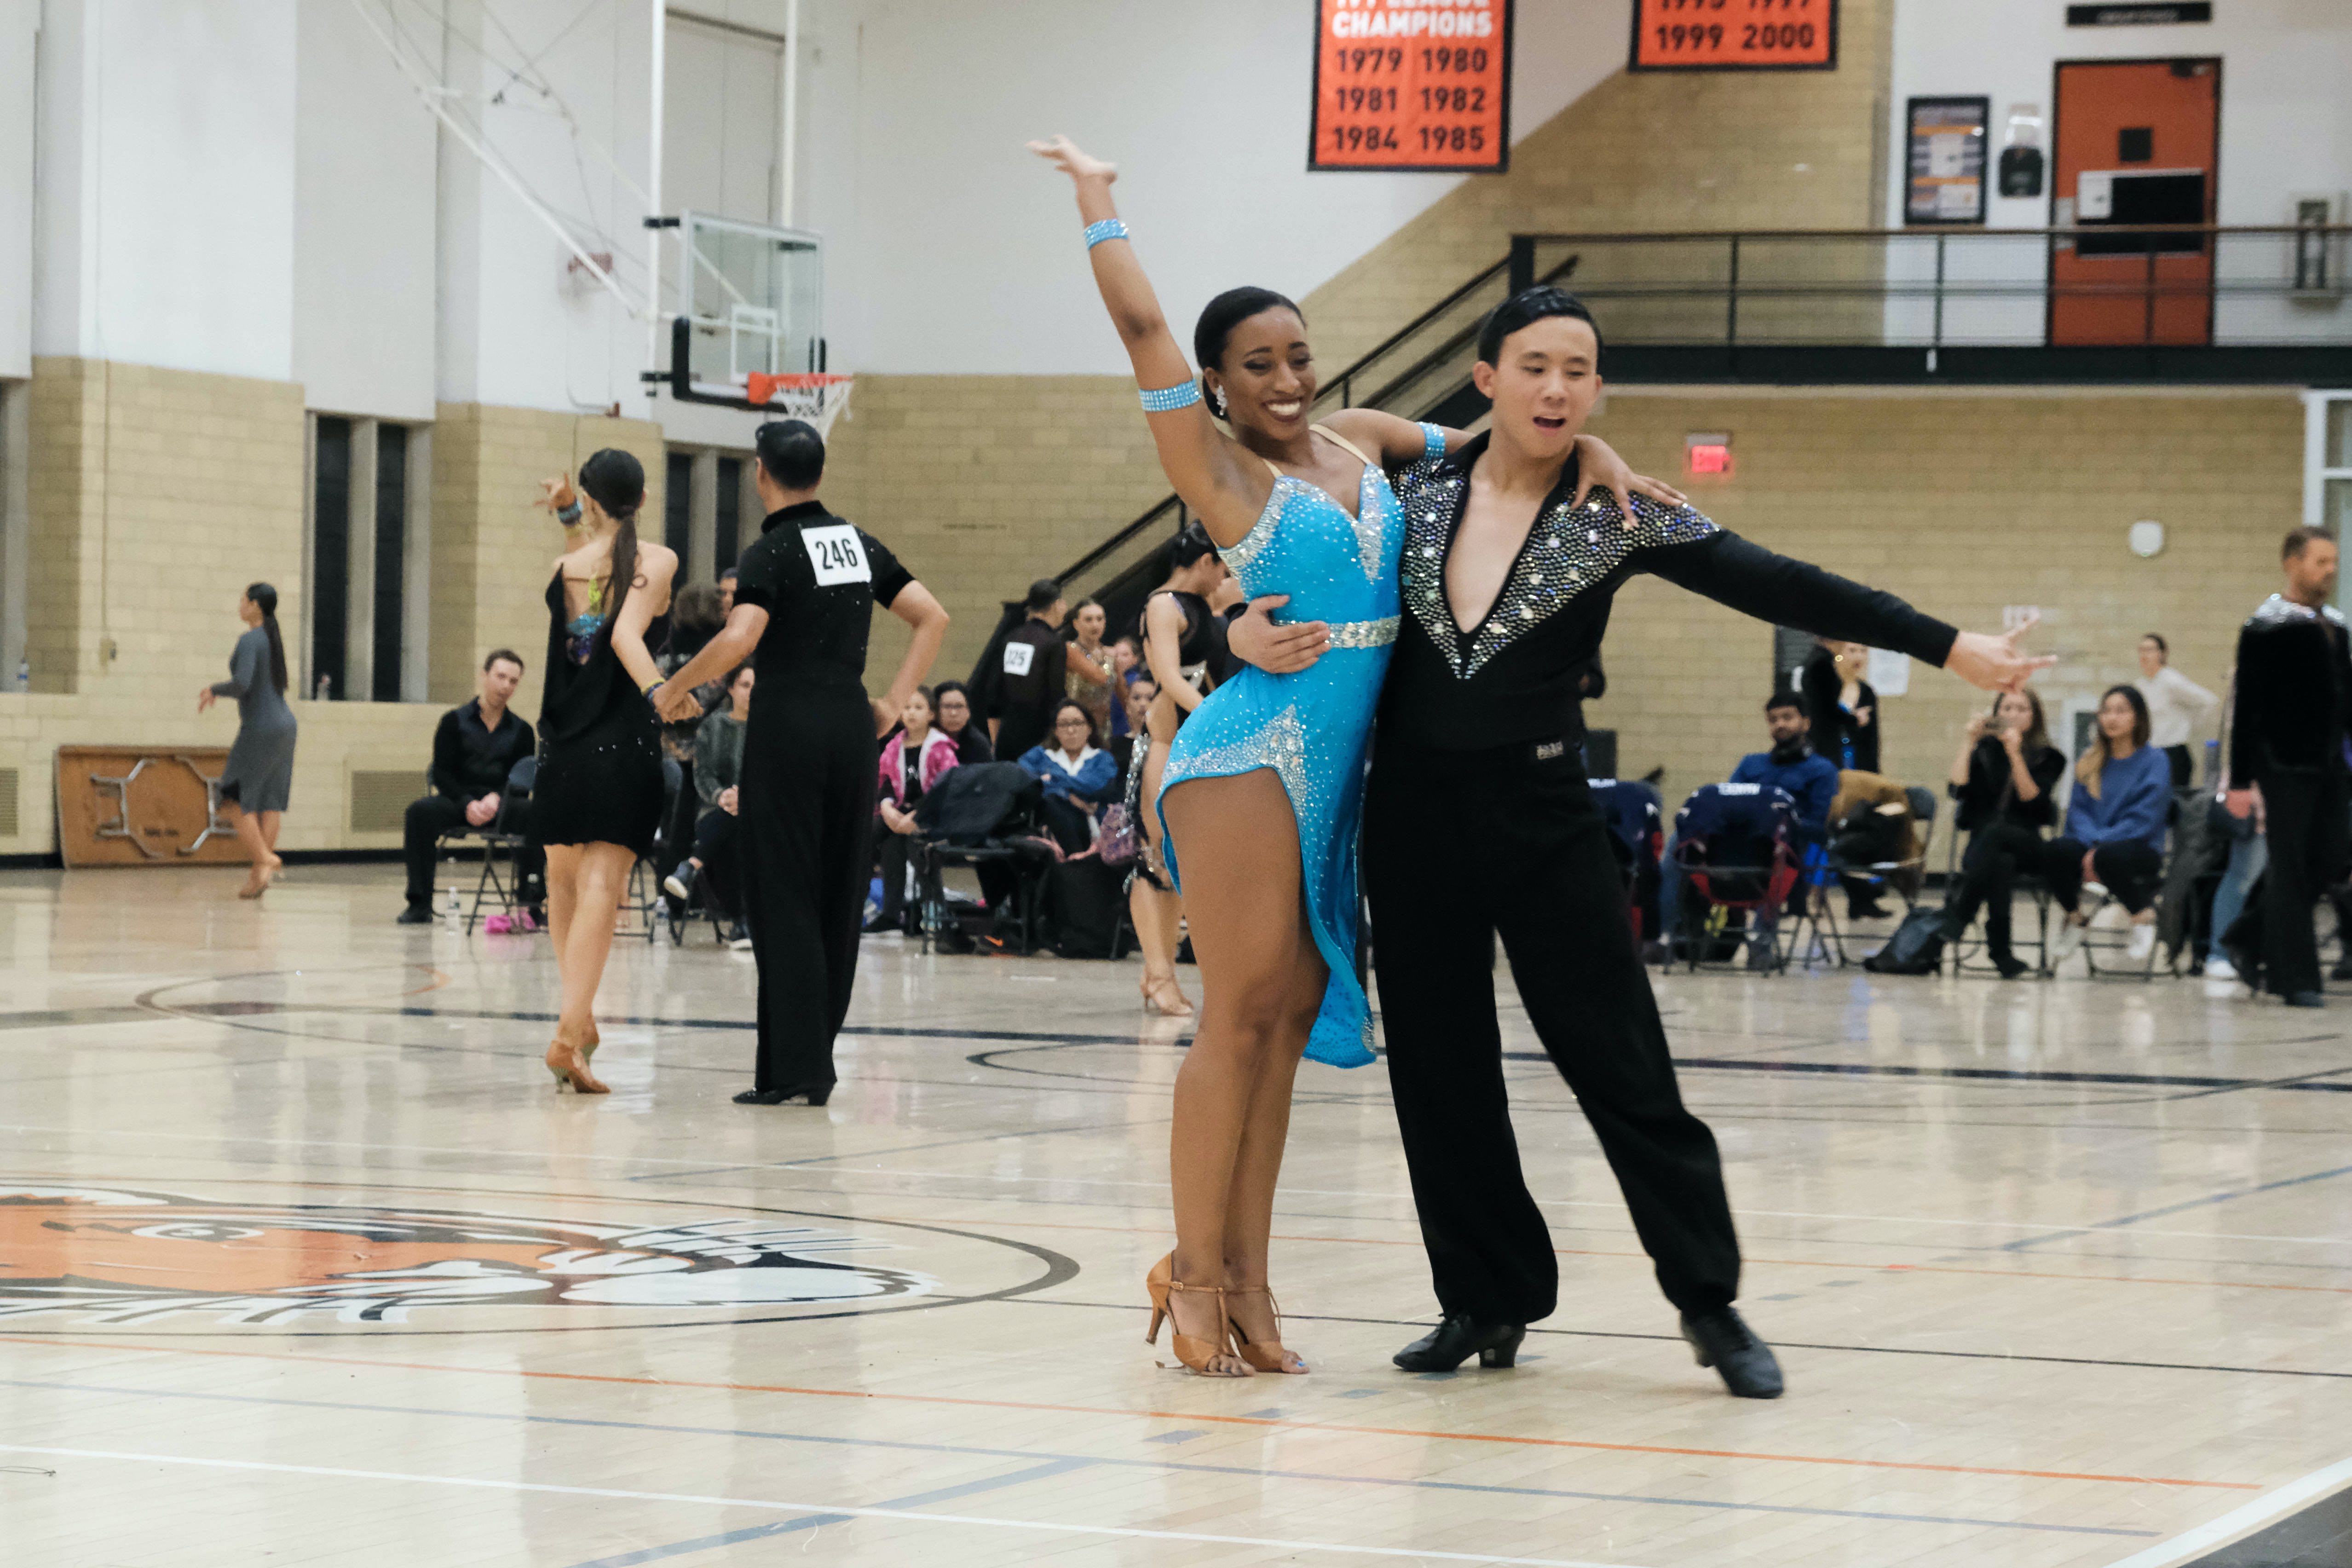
[0,1335,2263,1493]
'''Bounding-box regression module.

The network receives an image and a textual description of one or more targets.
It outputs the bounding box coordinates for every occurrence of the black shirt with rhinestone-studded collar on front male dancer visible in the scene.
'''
[1381,435,1959,752]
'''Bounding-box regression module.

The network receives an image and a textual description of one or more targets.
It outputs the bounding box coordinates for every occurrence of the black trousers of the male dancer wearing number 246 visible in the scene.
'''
[736,684,877,1089]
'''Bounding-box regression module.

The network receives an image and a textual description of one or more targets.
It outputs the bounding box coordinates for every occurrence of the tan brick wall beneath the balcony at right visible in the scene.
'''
[1585,392,2303,823]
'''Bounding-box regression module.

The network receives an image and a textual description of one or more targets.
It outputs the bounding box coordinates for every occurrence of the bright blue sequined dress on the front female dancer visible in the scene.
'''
[1159,426,1447,1067]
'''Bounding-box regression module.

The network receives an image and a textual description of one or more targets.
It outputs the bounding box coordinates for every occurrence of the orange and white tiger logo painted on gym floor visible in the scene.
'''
[0,1180,939,1328]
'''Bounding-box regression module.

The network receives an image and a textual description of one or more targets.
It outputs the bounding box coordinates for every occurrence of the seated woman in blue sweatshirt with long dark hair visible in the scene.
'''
[2039,686,2173,964]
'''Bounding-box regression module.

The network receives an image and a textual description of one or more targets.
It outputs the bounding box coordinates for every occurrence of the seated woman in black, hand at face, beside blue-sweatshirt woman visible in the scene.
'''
[1940,691,2065,980]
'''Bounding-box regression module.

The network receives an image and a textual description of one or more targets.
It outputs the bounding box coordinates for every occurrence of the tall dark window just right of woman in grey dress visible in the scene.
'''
[296,414,433,703]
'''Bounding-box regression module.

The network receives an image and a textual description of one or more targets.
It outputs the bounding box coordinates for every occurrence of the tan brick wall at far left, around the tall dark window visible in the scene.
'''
[0,357,663,856]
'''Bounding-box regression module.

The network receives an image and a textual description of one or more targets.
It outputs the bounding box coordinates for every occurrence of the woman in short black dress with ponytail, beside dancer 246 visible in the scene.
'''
[531,447,677,1095]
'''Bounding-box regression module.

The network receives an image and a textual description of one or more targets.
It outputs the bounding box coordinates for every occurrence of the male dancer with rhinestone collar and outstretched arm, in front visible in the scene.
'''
[1237,287,2049,1399]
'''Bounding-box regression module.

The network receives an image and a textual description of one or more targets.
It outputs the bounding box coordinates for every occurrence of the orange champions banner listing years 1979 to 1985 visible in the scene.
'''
[1308,0,1512,174]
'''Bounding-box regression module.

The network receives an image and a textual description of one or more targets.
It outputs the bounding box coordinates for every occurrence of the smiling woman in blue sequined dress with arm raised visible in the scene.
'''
[1030,136,1674,1378]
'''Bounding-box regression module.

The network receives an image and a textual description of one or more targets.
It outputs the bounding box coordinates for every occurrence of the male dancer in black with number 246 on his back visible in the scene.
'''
[654,418,948,1105]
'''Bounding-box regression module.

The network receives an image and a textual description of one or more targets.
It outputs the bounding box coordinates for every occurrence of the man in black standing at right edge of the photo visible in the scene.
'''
[2225,527,2352,1006]
